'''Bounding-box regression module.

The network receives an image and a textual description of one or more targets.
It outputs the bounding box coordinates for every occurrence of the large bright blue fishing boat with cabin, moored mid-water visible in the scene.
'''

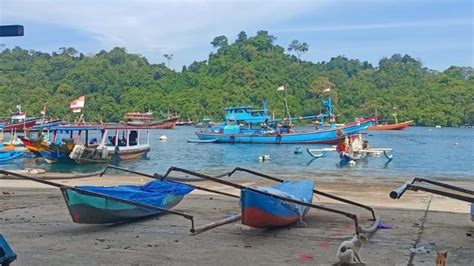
[196,97,373,144]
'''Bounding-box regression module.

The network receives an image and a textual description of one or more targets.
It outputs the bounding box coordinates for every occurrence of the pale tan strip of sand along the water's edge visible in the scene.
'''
[0,175,474,213]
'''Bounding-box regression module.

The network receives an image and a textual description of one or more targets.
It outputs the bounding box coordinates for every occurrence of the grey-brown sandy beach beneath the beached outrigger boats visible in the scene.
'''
[0,176,474,265]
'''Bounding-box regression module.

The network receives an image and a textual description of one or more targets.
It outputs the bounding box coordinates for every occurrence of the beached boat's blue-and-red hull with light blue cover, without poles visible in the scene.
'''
[240,180,314,228]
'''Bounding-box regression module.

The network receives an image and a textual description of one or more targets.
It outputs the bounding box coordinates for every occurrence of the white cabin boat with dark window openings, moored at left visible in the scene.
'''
[69,124,150,164]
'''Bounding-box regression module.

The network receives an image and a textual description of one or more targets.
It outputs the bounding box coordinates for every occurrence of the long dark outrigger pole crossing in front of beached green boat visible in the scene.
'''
[0,169,194,230]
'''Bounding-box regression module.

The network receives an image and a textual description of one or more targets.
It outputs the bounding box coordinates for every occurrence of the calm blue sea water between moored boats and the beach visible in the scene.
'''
[0,126,474,180]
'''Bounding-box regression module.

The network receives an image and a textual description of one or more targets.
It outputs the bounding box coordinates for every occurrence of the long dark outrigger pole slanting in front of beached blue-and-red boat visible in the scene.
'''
[163,167,380,234]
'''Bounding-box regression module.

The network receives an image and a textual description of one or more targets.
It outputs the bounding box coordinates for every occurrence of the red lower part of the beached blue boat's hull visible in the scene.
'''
[242,208,300,228]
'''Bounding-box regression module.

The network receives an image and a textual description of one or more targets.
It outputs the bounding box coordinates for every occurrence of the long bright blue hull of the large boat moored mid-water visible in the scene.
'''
[196,121,372,144]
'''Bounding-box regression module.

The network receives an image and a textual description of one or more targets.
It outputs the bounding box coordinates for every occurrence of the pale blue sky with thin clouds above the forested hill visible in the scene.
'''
[0,0,474,71]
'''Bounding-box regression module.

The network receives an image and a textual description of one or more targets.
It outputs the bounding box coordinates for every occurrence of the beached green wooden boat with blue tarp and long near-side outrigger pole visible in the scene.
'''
[0,169,194,225]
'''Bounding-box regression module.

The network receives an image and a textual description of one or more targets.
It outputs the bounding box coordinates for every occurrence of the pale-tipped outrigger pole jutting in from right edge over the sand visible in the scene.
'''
[390,177,474,203]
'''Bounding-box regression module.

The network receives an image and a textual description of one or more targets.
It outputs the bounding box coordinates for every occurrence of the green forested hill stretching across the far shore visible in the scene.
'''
[0,31,474,126]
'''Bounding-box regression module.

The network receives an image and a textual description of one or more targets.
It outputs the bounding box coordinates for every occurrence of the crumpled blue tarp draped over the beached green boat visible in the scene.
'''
[77,180,193,207]
